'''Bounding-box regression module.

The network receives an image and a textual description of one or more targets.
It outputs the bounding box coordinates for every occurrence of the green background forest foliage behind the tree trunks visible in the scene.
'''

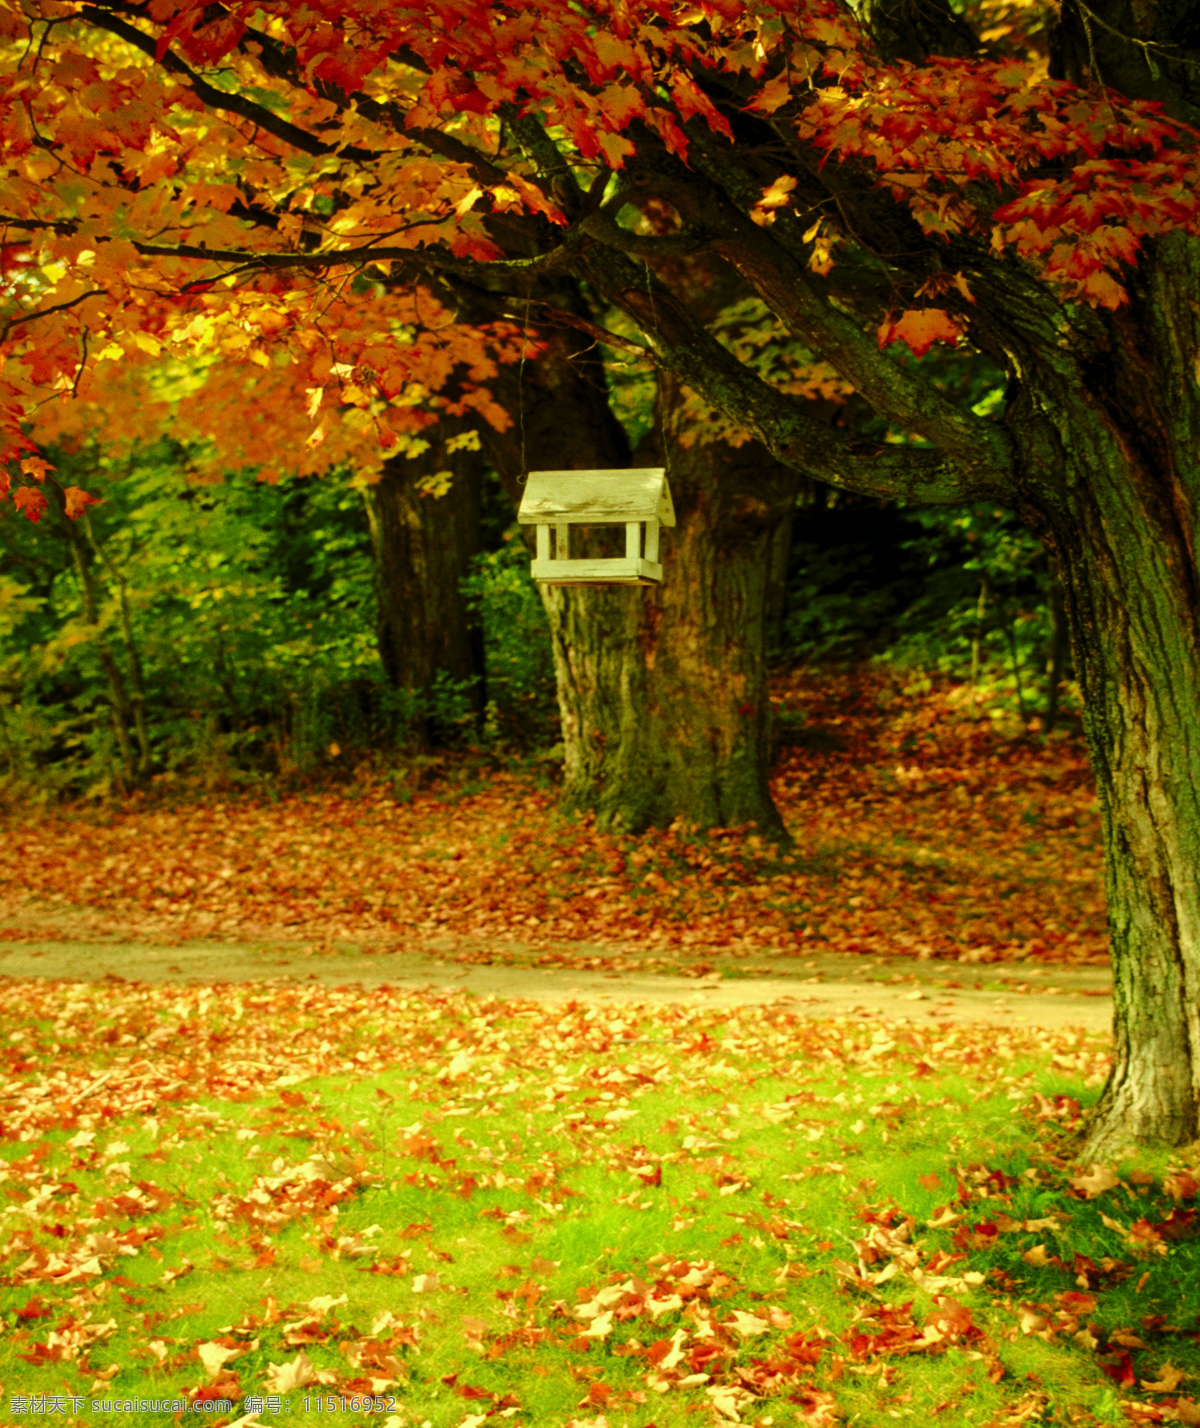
[0,338,1077,798]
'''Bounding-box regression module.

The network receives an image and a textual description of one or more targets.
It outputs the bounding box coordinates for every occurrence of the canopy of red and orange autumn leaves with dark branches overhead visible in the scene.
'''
[0,0,1200,520]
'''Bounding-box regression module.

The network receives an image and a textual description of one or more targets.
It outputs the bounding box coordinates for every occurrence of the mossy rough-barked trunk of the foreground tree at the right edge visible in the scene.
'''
[1011,236,1200,1155]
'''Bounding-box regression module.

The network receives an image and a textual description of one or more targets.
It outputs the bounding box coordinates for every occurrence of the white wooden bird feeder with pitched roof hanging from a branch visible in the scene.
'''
[517,466,674,585]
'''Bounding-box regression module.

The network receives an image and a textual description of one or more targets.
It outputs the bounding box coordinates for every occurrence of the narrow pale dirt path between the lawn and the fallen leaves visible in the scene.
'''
[0,931,1111,1032]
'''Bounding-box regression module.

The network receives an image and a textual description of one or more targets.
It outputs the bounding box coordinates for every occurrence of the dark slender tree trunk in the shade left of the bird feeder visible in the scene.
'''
[367,417,487,745]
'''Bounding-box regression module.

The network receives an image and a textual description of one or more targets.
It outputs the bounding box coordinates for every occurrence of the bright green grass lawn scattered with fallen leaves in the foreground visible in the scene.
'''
[0,981,1200,1428]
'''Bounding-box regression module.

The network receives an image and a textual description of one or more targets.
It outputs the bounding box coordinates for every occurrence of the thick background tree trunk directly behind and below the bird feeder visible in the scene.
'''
[544,382,799,841]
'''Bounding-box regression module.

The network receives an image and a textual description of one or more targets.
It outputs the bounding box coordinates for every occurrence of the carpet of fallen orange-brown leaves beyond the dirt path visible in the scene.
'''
[0,671,1107,975]
